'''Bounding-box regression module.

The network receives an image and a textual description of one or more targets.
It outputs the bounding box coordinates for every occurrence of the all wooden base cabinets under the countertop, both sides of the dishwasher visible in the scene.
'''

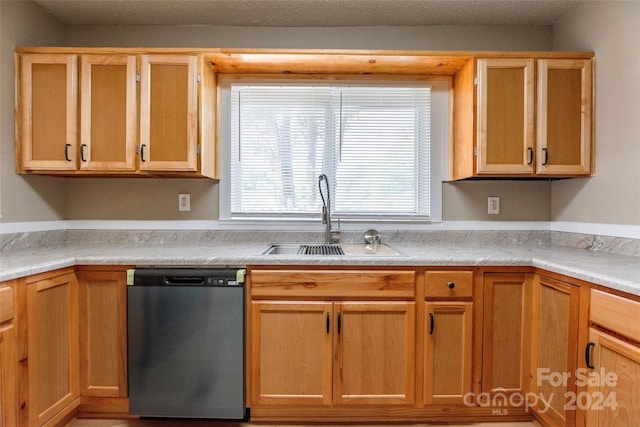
[0,267,640,427]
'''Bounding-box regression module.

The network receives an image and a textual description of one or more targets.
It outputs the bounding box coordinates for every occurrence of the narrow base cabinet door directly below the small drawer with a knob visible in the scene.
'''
[424,302,473,405]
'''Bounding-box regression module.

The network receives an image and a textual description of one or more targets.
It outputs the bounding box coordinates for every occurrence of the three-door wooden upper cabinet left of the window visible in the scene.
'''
[16,49,217,178]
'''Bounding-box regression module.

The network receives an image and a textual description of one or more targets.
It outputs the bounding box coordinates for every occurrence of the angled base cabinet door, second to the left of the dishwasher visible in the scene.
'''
[27,273,79,425]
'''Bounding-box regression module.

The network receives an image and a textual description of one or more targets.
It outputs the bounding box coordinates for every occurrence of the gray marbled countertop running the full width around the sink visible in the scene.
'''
[0,242,640,296]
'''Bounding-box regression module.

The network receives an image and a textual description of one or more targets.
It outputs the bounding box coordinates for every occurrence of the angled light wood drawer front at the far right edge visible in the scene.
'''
[589,289,640,342]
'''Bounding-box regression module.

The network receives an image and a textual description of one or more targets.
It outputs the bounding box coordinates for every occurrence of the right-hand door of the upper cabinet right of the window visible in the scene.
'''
[536,59,592,175]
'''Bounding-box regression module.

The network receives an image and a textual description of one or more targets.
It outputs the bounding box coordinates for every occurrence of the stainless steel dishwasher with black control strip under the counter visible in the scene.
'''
[127,268,245,419]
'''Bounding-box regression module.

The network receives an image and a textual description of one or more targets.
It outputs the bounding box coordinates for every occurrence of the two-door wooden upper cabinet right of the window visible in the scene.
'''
[452,58,593,179]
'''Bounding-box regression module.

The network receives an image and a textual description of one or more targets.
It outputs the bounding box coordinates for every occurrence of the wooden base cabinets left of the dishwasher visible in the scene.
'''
[0,267,127,426]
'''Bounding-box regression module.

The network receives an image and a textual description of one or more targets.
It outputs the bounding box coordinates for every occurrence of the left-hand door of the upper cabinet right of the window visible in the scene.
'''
[476,59,535,175]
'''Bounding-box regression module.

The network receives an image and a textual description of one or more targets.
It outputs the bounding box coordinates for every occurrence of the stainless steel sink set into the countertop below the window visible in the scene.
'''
[261,243,404,257]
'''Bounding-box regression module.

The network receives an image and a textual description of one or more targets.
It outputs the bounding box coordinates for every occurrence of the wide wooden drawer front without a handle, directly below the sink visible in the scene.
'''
[249,270,415,299]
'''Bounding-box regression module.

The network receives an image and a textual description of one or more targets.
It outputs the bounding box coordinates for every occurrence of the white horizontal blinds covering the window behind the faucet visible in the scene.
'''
[230,84,431,220]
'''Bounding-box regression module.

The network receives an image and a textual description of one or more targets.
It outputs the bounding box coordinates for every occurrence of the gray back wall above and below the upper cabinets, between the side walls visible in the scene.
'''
[61,26,552,221]
